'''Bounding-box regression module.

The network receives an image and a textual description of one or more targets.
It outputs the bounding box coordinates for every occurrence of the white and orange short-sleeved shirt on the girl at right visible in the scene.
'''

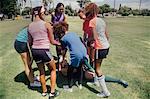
[89,17,110,49]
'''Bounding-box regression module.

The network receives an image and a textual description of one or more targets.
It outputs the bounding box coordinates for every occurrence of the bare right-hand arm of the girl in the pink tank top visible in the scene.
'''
[45,23,60,45]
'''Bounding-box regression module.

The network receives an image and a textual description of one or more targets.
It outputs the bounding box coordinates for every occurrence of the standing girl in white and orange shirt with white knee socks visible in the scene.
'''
[85,3,110,97]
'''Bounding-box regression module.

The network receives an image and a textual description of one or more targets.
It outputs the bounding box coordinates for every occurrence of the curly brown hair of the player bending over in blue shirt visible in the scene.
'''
[53,22,69,39]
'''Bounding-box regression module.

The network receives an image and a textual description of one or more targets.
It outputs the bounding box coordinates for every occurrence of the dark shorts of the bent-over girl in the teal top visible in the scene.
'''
[14,40,29,53]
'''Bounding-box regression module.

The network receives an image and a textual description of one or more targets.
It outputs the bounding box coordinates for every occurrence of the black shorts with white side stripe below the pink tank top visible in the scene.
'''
[32,49,53,64]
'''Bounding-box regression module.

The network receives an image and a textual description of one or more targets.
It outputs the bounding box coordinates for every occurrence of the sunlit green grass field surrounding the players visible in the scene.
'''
[0,17,150,99]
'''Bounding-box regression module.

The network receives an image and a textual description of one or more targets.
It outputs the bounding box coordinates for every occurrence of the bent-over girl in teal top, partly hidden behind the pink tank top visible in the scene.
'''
[14,27,41,87]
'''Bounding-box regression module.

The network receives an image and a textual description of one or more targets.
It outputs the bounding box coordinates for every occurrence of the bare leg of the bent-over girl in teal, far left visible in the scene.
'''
[20,52,34,83]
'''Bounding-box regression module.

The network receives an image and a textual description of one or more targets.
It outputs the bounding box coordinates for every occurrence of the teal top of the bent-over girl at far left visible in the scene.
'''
[16,28,28,42]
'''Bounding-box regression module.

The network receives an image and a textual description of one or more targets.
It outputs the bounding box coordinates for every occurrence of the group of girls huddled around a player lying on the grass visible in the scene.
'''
[14,3,110,97]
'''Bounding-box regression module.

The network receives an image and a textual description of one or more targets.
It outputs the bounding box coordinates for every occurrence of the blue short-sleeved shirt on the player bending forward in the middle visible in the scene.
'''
[61,32,87,67]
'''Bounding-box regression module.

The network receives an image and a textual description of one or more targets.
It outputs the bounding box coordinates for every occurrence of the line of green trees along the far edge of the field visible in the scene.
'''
[0,0,150,18]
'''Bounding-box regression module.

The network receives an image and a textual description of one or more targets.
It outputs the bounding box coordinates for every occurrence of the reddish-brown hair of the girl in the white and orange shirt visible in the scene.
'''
[85,3,99,18]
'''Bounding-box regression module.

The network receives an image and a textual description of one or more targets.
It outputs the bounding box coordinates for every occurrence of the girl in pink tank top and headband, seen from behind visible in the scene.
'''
[28,6,60,97]
